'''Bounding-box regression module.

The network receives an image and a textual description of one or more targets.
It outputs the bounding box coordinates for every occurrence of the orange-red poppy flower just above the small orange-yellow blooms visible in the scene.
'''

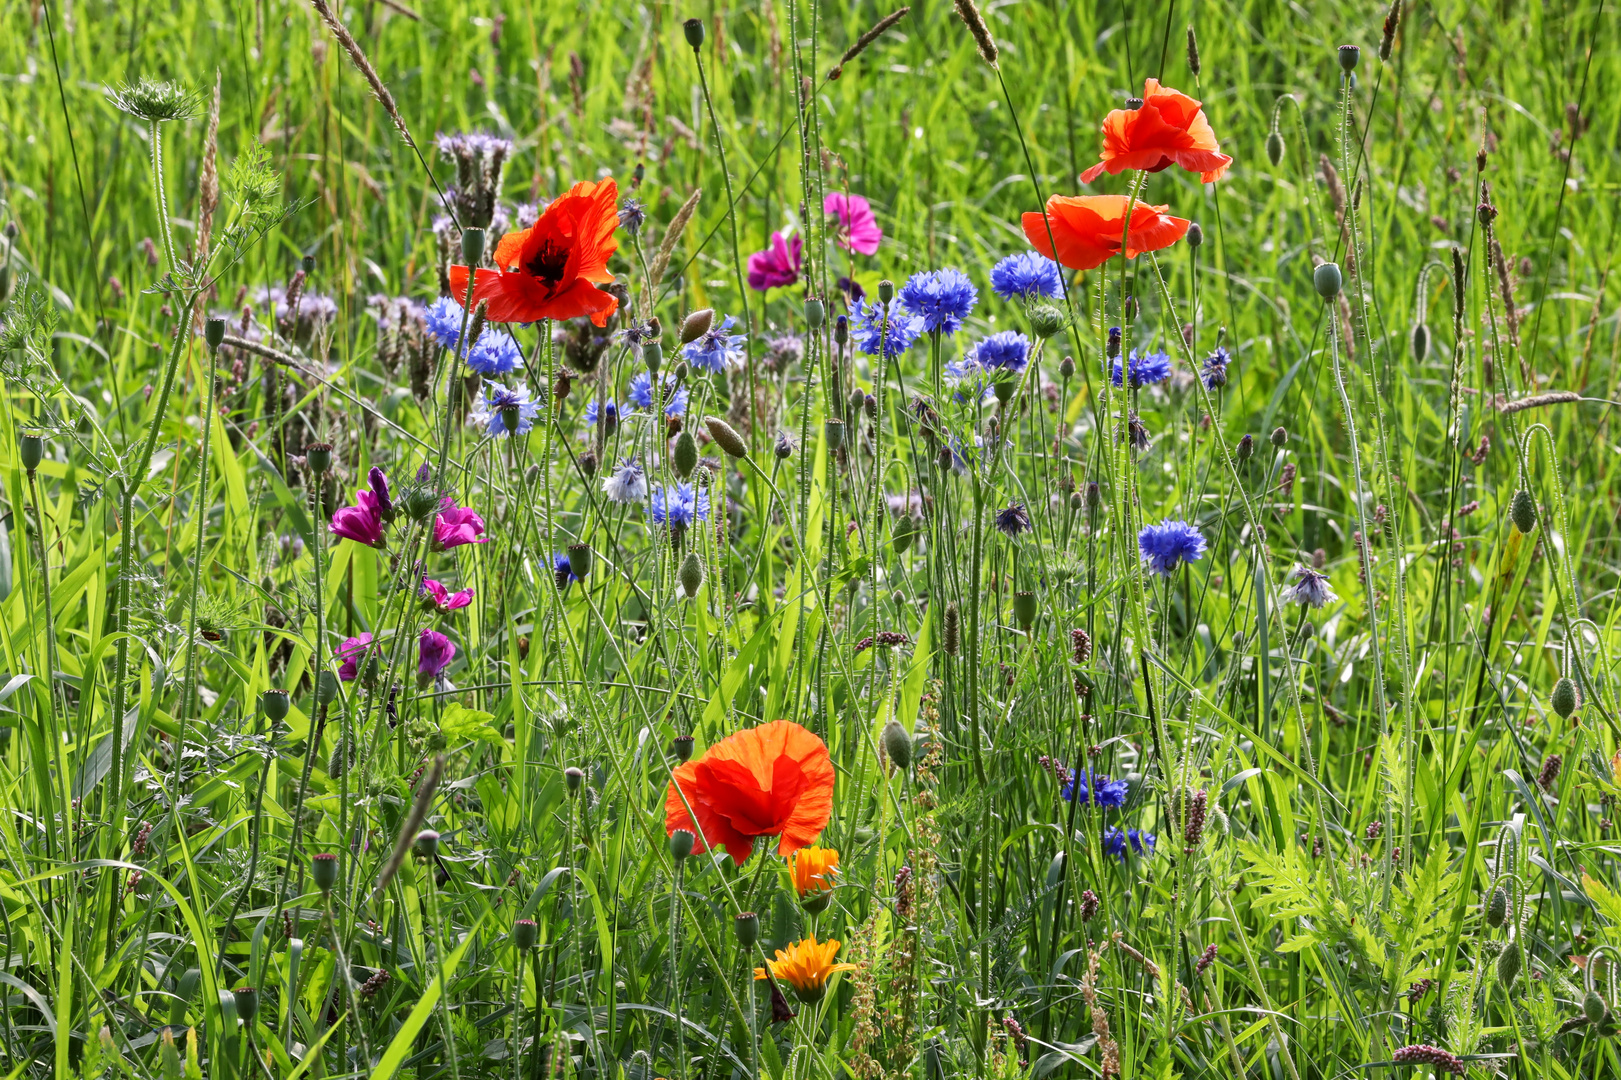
[665,720,833,864]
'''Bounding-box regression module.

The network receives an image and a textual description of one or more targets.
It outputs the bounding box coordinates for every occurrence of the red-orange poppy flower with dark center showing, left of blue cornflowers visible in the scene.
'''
[451,177,619,326]
